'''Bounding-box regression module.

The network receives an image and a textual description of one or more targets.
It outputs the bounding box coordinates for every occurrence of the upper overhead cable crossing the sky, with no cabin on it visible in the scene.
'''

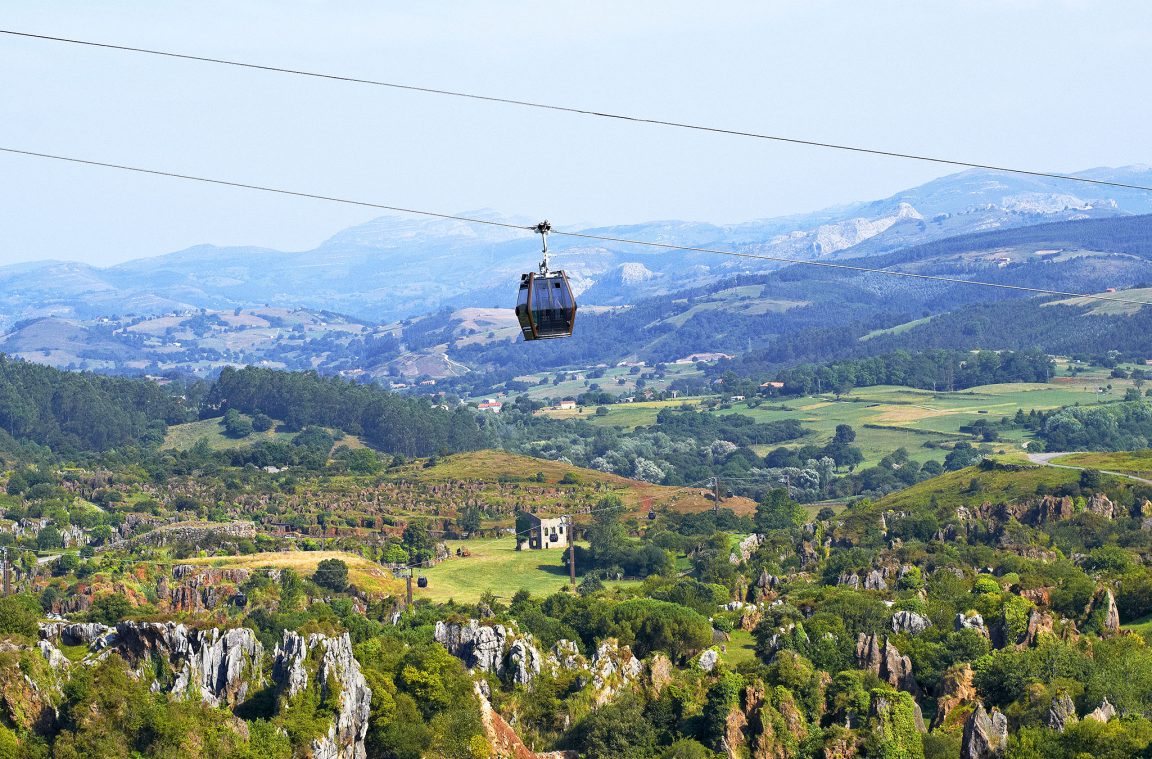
[0,29,1152,192]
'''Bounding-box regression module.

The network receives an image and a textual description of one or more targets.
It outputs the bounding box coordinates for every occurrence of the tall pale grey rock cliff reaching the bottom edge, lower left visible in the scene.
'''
[272,630,372,759]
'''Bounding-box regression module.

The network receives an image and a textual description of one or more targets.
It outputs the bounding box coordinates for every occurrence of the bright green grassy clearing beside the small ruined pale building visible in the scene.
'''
[415,537,627,604]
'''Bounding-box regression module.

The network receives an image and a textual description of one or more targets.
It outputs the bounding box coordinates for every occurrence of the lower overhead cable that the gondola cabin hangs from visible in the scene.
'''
[0,146,1152,306]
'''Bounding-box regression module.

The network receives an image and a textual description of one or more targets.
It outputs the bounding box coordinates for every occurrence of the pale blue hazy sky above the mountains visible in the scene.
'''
[0,0,1152,265]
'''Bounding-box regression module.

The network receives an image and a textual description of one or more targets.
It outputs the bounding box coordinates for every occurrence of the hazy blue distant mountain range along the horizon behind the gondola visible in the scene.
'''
[0,166,1152,326]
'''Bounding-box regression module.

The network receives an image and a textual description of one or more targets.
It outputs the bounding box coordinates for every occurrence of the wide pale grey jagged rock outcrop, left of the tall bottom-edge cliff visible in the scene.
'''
[114,622,264,707]
